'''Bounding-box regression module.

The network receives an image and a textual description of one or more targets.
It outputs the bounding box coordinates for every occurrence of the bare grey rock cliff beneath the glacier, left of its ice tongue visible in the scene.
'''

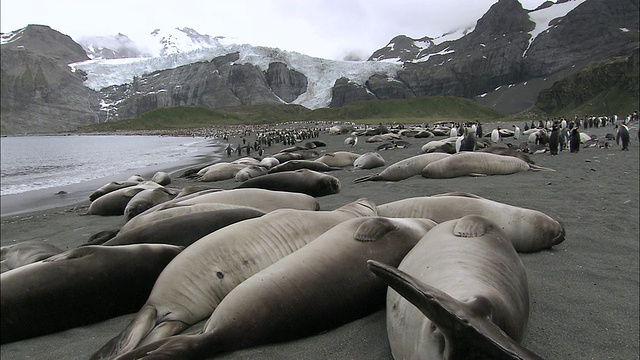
[100,53,288,120]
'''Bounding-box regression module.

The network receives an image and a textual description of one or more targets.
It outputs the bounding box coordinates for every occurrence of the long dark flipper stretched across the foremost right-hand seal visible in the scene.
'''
[367,260,542,360]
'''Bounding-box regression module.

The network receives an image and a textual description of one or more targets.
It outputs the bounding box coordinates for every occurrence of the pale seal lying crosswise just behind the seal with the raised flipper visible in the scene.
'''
[378,193,565,252]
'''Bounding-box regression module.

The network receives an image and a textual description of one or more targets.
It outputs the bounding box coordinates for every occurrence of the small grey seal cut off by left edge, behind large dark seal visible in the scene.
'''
[0,240,63,272]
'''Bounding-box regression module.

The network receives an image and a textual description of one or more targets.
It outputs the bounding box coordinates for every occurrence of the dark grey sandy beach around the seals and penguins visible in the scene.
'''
[0,124,640,360]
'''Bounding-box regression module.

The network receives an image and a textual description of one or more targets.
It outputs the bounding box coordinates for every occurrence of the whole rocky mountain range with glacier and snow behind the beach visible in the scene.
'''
[0,0,639,134]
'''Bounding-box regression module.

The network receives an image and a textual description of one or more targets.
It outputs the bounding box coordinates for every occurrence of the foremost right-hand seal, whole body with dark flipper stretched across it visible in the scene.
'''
[369,215,541,359]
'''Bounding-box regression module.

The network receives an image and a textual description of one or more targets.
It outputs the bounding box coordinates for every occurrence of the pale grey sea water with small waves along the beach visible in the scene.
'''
[0,135,223,195]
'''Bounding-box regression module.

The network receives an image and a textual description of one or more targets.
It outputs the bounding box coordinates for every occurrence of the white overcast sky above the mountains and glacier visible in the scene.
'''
[0,0,544,60]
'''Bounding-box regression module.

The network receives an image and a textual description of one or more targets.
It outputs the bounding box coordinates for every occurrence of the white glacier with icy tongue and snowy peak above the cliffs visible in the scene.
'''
[69,28,402,109]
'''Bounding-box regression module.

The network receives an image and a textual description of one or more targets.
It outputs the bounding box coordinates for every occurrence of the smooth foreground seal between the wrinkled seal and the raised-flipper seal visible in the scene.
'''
[112,217,436,359]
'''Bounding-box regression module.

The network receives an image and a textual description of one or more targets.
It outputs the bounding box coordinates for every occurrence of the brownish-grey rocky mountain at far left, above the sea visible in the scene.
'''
[0,25,99,134]
